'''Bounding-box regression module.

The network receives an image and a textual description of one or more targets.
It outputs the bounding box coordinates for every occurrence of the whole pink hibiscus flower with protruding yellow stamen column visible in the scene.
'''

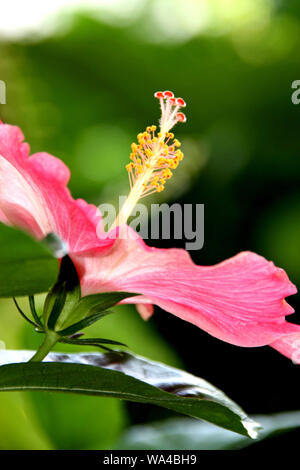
[0,92,300,363]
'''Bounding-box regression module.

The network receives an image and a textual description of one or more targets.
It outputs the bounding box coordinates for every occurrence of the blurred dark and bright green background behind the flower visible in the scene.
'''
[0,0,300,449]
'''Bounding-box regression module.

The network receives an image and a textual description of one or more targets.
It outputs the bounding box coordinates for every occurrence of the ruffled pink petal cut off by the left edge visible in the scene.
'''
[0,124,113,254]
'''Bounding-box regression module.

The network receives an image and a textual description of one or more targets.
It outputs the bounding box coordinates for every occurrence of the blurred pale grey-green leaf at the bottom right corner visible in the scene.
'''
[115,411,300,450]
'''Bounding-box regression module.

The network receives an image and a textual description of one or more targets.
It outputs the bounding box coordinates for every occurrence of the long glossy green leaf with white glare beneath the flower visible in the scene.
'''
[0,350,259,438]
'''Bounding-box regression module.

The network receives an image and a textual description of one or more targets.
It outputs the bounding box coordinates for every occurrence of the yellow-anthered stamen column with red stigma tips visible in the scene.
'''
[111,91,186,229]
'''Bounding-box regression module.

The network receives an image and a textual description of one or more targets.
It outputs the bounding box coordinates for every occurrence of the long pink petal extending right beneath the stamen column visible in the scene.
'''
[74,231,298,346]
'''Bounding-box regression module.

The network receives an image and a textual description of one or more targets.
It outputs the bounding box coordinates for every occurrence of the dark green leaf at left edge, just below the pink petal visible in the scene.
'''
[0,224,58,297]
